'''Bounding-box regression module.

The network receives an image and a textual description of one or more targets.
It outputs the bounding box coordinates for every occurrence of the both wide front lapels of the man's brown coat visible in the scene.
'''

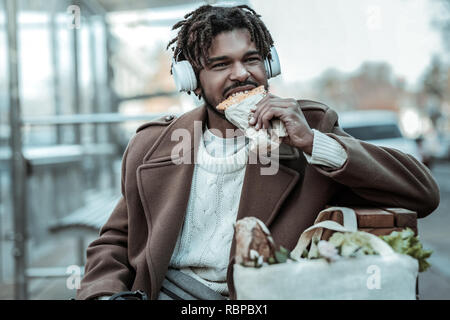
[137,106,300,298]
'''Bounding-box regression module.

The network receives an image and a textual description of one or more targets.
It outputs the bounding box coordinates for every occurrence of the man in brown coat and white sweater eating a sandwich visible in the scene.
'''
[77,6,439,299]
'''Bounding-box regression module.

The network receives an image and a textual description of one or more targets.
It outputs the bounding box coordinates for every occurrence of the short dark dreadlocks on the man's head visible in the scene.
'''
[166,5,273,91]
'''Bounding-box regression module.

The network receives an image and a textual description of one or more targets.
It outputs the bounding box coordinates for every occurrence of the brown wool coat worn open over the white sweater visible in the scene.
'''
[77,100,439,299]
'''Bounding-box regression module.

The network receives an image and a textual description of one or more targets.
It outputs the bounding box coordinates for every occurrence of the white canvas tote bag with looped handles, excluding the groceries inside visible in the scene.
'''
[233,207,418,300]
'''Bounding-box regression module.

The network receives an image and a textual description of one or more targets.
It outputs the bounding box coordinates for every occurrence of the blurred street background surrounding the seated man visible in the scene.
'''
[0,0,450,299]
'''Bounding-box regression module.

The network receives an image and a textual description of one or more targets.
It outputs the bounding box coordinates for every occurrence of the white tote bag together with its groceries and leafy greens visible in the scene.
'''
[234,207,431,300]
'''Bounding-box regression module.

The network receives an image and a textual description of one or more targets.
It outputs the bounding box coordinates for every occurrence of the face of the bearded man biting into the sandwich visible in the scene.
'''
[196,29,267,113]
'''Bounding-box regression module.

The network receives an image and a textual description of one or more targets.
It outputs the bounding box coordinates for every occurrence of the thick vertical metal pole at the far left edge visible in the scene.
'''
[6,0,28,300]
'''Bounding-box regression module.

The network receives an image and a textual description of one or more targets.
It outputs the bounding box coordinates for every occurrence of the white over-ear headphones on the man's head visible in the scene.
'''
[172,47,281,91]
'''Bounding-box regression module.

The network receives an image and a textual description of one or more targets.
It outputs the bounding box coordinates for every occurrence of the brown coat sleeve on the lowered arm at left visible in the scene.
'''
[77,141,134,299]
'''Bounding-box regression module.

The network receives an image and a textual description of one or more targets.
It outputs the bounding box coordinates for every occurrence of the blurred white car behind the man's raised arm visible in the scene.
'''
[339,110,424,165]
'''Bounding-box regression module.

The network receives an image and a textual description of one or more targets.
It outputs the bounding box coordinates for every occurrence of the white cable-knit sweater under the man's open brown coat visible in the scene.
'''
[170,130,248,295]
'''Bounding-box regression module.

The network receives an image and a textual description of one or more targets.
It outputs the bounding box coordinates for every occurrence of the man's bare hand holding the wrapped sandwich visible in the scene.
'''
[249,93,314,154]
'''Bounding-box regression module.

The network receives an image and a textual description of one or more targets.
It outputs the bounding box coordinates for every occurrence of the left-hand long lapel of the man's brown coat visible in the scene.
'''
[137,108,206,299]
